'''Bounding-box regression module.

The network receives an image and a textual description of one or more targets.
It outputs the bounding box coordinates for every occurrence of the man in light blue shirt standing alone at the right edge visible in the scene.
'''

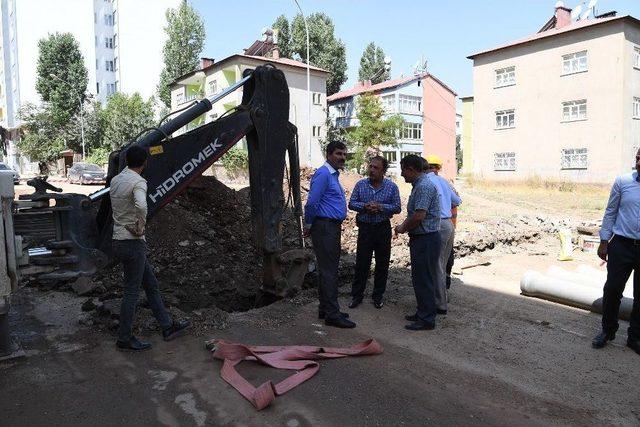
[592,150,640,354]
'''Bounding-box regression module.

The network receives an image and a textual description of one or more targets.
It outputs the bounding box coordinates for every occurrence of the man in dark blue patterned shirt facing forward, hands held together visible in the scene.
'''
[349,156,401,308]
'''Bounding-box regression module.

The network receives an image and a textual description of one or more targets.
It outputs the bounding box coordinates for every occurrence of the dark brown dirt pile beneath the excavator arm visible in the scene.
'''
[72,177,304,336]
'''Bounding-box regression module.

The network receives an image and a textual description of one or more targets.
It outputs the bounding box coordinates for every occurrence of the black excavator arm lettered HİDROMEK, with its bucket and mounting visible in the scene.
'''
[3,65,310,298]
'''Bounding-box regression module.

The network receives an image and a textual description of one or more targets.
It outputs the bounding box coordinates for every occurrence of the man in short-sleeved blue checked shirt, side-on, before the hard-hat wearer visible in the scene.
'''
[395,154,441,331]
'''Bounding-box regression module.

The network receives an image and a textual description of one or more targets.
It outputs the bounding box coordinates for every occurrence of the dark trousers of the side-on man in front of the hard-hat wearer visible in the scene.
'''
[409,231,441,323]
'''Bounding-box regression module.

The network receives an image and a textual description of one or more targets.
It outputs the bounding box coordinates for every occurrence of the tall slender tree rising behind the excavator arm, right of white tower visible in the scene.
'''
[158,1,205,107]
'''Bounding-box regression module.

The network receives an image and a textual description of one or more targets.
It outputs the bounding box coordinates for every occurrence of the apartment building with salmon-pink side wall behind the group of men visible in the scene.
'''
[328,73,457,178]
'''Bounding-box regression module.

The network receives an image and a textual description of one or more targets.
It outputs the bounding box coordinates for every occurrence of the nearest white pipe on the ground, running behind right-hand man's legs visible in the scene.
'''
[520,271,633,320]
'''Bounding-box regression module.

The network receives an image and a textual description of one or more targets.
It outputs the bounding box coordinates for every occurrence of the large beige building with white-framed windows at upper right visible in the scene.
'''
[463,7,640,183]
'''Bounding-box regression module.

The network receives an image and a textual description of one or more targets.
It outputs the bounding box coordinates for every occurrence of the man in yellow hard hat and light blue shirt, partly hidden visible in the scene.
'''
[426,154,462,314]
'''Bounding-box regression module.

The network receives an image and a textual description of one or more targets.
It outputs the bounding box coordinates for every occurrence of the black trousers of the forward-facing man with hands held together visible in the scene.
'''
[351,220,391,302]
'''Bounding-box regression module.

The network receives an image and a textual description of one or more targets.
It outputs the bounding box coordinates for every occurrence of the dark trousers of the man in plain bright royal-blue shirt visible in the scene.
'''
[311,218,342,319]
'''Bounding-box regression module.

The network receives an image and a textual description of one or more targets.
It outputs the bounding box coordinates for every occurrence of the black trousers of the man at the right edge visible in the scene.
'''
[602,236,640,341]
